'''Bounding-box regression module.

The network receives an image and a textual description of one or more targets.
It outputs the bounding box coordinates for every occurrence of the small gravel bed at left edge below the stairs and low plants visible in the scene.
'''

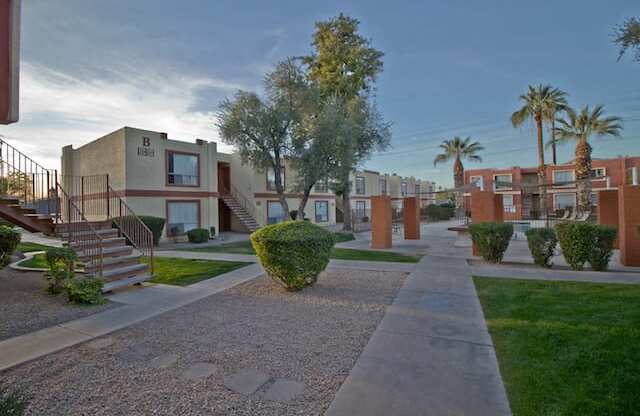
[0,267,117,340]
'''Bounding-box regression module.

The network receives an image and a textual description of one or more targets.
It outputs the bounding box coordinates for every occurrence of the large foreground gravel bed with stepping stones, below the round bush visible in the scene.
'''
[1,270,406,416]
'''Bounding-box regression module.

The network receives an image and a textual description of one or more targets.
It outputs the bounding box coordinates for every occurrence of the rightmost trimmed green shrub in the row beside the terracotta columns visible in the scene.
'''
[555,222,618,271]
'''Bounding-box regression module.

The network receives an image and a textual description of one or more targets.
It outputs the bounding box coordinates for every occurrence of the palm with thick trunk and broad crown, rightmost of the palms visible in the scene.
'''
[555,105,622,212]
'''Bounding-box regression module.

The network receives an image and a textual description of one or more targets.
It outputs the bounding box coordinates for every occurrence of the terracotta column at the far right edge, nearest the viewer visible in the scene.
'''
[618,185,640,266]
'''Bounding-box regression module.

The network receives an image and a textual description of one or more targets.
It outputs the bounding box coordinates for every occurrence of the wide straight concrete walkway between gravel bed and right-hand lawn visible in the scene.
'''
[327,256,510,416]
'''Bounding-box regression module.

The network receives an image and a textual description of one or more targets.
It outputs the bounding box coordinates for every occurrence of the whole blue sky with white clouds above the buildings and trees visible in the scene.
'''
[0,0,640,186]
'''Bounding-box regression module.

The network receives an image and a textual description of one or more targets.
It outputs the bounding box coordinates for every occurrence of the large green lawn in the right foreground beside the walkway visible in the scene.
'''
[474,277,640,416]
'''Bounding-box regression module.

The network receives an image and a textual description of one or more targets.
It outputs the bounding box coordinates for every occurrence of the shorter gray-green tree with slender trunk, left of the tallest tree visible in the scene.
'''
[217,59,314,218]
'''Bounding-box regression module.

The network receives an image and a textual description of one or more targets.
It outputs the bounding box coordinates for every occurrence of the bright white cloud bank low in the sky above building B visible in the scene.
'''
[0,62,251,167]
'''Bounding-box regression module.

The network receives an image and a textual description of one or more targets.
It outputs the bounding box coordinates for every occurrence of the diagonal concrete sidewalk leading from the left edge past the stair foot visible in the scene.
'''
[0,264,264,371]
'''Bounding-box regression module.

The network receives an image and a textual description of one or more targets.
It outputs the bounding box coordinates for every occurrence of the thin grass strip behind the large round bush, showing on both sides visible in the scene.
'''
[180,241,420,263]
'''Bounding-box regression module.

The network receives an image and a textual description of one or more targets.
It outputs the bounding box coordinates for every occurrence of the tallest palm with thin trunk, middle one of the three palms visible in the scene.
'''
[511,84,566,213]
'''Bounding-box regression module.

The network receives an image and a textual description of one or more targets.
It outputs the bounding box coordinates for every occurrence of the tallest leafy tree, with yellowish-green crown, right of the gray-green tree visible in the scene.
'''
[303,14,390,230]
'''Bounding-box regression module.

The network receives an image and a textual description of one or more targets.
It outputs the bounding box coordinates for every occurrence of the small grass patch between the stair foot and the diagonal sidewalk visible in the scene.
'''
[151,257,252,286]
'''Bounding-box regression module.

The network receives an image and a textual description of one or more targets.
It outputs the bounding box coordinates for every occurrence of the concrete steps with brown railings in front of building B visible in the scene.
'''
[56,221,153,292]
